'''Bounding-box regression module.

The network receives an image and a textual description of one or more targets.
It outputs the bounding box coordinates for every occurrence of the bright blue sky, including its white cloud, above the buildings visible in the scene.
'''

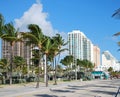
[0,0,120,60]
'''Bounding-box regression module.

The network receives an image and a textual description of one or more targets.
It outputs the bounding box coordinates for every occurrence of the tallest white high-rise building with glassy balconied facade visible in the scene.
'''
[68,30,93,62]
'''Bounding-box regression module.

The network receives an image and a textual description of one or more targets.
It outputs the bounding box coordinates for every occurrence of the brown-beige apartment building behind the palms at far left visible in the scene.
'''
[2,32,32,64]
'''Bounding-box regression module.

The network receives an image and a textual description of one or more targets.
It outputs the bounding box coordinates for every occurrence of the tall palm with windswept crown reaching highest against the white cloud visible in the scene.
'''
[22,24,45,88]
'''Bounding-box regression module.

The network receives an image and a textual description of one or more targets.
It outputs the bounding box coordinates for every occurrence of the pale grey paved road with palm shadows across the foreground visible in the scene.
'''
[0,79,120,97]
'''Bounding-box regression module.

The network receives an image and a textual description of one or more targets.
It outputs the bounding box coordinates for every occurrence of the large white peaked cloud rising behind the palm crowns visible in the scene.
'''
[15,0,54,36]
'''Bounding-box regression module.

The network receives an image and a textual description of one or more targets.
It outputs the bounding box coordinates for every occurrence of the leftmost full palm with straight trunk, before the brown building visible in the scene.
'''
[1,23,21,85]
